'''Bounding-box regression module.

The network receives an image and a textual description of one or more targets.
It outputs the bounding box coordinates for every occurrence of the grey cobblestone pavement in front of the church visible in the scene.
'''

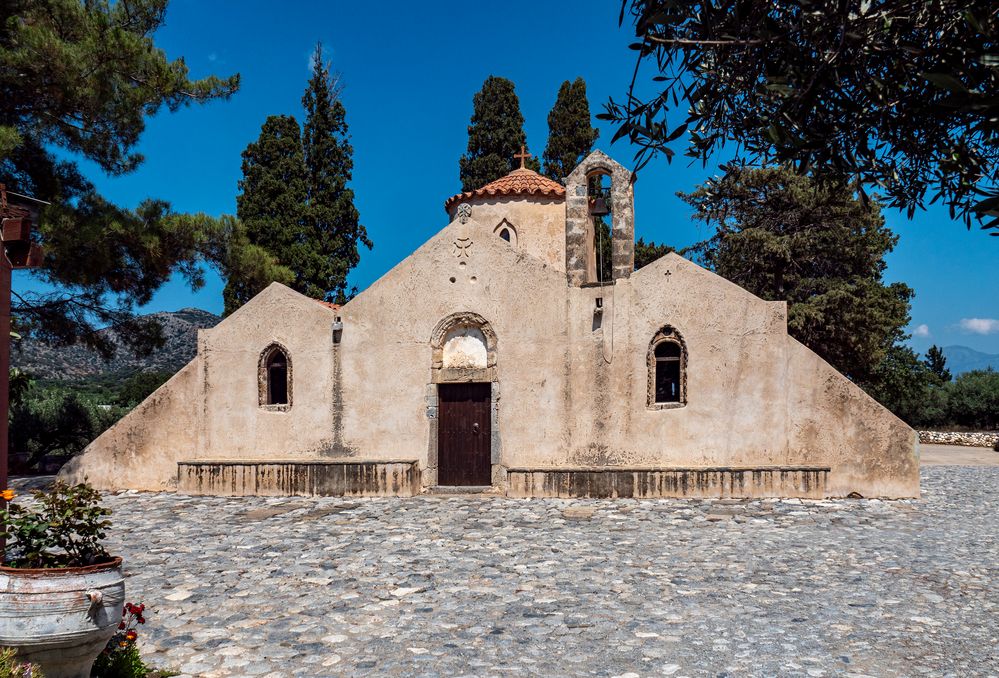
[54,467,999,678]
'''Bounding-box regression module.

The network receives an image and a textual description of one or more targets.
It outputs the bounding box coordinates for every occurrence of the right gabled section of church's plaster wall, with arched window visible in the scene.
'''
[560,254,919,497]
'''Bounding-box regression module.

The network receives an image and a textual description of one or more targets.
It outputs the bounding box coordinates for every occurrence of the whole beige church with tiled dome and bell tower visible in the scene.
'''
[60,151,919,498]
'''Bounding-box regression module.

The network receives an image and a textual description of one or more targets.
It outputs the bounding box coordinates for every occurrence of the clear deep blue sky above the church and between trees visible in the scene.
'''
[15,0,999,353]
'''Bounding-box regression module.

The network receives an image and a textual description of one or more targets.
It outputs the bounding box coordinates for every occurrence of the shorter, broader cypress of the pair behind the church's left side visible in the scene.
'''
[223,115,308,315]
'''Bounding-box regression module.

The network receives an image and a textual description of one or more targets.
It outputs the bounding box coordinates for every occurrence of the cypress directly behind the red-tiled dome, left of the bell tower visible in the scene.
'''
[458,75,541,191]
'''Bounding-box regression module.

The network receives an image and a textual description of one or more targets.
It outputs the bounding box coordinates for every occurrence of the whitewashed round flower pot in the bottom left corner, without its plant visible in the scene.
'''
[0,558,125,678]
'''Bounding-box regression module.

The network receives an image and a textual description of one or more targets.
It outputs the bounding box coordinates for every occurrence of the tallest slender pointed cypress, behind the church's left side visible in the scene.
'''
[298,44,371,302]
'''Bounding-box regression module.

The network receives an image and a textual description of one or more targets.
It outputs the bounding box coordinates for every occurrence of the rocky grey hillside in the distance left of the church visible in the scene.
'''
[11,308,221,380]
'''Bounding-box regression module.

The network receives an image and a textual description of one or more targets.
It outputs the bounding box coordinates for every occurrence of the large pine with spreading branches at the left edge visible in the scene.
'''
[0,0,239,357]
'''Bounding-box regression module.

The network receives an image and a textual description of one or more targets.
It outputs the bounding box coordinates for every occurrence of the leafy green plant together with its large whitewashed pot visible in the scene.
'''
[0,482,125,678]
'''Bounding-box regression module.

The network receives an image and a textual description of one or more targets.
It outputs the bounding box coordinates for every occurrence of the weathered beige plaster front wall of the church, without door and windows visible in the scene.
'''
[64,150,919,497]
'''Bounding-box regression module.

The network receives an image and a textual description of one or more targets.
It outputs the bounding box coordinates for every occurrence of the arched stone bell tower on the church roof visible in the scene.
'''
[565,151,635,287]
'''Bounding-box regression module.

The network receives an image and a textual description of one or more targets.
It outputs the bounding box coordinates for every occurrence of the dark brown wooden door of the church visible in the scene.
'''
[437,384,492,485]
